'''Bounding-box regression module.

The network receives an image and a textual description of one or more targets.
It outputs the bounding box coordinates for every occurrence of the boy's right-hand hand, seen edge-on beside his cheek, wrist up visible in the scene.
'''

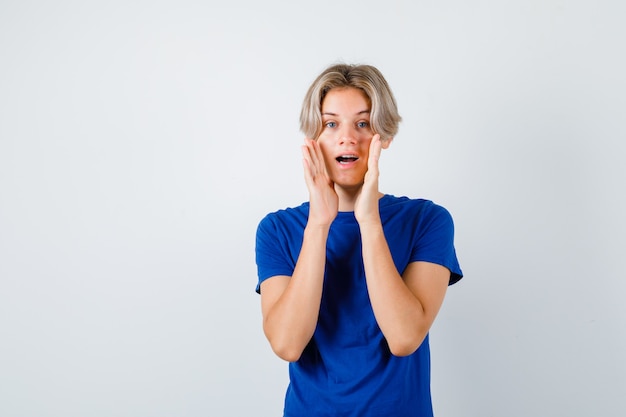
[354,134,382,226]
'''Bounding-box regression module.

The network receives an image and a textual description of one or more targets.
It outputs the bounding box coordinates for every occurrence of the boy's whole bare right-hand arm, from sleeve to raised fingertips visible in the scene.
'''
[355,135,450,356]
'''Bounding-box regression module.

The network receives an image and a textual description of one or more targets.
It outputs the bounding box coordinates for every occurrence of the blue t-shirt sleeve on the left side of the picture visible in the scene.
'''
[255,215,295,294]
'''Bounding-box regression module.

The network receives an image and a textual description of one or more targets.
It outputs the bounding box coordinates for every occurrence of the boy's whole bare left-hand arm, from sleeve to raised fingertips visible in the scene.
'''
[261,140,339,362]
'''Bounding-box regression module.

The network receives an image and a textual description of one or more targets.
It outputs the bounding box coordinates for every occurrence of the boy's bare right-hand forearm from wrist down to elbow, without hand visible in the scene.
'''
[361,222,431,356]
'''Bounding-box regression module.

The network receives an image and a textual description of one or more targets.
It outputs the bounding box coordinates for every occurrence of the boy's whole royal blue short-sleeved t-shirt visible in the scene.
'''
[256,195,463,417]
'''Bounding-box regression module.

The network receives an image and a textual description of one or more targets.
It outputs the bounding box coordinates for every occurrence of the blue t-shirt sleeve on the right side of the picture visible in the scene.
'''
[411,204,463,285]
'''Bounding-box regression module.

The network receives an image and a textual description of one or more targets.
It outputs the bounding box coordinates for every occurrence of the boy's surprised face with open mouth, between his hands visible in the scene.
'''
[317,87,386,189]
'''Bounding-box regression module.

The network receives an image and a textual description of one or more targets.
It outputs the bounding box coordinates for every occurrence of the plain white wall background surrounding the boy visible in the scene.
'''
[0,0,626,417]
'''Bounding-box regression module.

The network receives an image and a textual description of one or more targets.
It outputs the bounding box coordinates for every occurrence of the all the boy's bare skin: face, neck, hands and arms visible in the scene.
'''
[261,87,450,362]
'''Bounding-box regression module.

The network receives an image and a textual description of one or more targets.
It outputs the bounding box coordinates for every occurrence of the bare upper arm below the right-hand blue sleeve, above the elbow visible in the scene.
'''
[402,261,450,330]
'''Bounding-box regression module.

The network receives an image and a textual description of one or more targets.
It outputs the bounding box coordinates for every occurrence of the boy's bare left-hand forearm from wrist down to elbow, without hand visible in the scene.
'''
[263,226,329,361]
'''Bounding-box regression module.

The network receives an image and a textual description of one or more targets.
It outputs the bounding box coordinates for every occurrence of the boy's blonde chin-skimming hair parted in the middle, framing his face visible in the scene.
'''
[300,64,402,140]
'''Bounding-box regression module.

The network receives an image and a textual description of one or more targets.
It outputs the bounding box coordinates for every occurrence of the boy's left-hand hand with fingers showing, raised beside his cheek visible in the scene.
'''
[302,139,339,226]
